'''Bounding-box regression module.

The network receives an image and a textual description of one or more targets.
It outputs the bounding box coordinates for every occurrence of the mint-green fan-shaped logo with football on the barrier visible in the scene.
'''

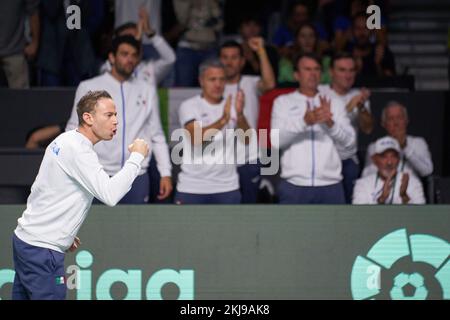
[351,229,450,300]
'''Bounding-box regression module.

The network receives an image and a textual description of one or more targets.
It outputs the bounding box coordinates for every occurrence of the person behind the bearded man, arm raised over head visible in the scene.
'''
[100,10,175,86]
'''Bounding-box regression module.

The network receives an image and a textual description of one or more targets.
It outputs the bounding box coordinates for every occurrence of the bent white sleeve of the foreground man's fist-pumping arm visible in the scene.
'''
[58,149,144,206]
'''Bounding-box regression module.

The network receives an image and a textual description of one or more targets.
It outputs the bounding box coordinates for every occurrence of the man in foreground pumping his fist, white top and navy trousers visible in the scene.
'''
[12,91,148,300]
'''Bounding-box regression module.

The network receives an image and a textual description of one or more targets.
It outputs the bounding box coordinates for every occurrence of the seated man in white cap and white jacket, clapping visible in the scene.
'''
[353,136,425,204]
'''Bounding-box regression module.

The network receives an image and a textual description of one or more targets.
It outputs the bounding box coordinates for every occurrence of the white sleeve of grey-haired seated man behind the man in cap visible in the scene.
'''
[403,138,433,177]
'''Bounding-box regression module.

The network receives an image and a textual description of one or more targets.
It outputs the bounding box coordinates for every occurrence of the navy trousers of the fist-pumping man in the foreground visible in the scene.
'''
[12,234,67,300]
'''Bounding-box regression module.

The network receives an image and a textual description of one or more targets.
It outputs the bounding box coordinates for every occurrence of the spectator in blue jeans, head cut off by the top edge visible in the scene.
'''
[173,0,223,87]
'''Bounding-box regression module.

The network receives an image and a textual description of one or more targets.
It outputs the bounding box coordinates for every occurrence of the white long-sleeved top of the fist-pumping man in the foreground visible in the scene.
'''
[15,130,144,252]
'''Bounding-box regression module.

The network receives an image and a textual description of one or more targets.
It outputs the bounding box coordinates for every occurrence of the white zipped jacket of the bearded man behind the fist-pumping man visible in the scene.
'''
[66,72,172,177]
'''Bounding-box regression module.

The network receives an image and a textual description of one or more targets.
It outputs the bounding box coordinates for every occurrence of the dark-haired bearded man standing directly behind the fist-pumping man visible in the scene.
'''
[66,36,172,204]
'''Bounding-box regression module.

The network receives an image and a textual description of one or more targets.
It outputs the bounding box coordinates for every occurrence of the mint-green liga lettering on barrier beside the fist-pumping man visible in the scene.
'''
[0,250,194,300]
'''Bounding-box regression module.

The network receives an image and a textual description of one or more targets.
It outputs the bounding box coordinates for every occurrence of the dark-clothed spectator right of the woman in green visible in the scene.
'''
[346,13,395,77]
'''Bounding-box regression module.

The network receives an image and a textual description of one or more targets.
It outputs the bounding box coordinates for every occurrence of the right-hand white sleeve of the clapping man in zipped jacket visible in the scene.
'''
[322,100,357,154]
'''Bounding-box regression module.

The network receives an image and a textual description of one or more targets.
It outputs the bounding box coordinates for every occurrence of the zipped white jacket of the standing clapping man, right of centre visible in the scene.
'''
[270,90,356,186]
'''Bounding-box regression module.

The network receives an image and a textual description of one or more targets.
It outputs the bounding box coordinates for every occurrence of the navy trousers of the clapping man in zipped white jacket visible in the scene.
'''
[278,179,345,204]
